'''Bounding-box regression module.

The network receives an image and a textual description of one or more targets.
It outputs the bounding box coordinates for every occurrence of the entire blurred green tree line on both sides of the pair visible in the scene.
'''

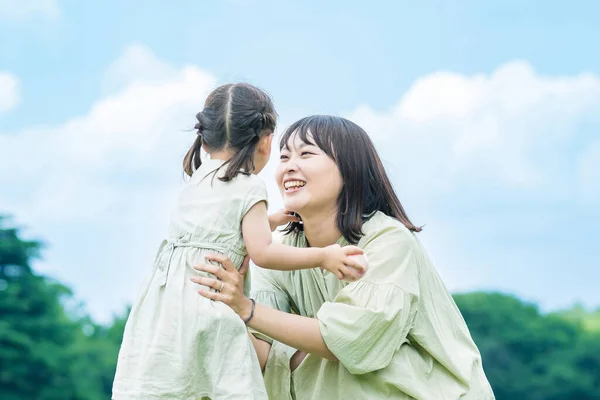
[0,216,600,400]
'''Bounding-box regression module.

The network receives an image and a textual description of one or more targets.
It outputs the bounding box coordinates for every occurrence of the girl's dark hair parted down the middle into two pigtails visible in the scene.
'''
[183,83,277,182]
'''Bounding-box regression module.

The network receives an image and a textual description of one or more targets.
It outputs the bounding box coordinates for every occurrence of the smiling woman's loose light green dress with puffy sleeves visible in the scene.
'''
[252,213,494,400]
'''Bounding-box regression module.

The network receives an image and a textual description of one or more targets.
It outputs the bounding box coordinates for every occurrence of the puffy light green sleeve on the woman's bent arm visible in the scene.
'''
[317,225,419,374]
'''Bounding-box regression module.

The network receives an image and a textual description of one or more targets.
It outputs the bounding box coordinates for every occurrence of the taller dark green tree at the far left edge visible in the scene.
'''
[0,218,77,400]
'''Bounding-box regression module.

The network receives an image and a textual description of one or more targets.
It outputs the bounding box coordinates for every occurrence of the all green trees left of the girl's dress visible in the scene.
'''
[0,217,125,400]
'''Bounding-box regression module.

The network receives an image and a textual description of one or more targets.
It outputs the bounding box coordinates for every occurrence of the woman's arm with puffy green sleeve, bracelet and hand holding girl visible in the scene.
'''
[198,221,422,374]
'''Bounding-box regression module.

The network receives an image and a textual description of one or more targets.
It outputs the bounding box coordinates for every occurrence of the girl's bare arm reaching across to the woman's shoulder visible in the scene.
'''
[242,201,364,279]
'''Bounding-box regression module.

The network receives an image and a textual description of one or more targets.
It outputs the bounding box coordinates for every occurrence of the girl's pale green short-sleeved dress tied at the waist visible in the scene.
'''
[112,160,268,400]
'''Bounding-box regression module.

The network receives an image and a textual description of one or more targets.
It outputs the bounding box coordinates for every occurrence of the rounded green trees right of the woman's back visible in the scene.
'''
[455,292,600,400]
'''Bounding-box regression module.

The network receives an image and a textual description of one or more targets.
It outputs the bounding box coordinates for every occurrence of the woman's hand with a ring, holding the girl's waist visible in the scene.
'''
[190,254,252,319]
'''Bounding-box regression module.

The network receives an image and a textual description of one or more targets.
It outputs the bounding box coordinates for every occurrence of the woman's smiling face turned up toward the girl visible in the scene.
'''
[275,134,343,219]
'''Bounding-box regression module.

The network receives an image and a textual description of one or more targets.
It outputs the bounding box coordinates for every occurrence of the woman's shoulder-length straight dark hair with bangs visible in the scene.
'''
[279,115,421,244]
